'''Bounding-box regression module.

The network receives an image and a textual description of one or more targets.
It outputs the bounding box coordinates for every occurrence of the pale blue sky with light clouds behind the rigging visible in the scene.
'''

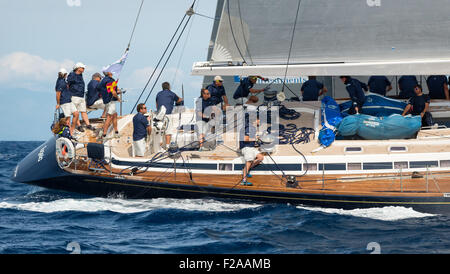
[0,0,216,141]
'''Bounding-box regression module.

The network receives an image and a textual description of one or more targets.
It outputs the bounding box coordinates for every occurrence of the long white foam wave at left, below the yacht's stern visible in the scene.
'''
[0,198,261,213]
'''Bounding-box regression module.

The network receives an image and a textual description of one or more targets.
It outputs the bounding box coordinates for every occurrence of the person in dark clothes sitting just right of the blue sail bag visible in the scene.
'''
[402,85,433,127]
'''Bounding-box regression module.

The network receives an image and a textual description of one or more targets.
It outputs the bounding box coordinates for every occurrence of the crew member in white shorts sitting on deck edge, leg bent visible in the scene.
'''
[239,113,264,186]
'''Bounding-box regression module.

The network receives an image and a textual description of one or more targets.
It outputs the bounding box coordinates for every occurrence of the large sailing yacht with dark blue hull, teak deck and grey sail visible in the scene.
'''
[12,0,450,213]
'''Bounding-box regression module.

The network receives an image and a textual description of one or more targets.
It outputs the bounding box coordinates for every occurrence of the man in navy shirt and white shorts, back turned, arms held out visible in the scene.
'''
[156,82,183,145]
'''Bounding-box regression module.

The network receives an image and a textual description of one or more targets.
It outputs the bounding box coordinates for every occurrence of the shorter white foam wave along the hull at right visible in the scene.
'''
[297,206,435,221]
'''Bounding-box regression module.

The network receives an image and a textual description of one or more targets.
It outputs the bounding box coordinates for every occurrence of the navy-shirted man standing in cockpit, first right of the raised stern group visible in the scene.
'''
[133,104,152,157]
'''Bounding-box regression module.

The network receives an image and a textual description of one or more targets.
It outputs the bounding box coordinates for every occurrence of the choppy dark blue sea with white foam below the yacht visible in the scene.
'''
[0,142,450,254]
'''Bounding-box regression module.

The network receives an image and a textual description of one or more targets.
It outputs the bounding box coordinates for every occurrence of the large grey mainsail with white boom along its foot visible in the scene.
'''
[193,0,450,75]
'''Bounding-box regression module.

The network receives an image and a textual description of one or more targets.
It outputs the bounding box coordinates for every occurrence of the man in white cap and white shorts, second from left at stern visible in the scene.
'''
[67,62,94,132]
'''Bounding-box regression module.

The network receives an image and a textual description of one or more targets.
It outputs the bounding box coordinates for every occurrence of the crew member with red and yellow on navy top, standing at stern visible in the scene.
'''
[98,71,120,140]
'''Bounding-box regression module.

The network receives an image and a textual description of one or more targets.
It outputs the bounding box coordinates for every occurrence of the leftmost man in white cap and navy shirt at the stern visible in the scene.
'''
[55,68,78,135]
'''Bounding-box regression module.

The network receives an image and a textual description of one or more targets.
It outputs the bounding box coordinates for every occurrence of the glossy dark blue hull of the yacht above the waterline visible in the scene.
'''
[12,139,450,214]
